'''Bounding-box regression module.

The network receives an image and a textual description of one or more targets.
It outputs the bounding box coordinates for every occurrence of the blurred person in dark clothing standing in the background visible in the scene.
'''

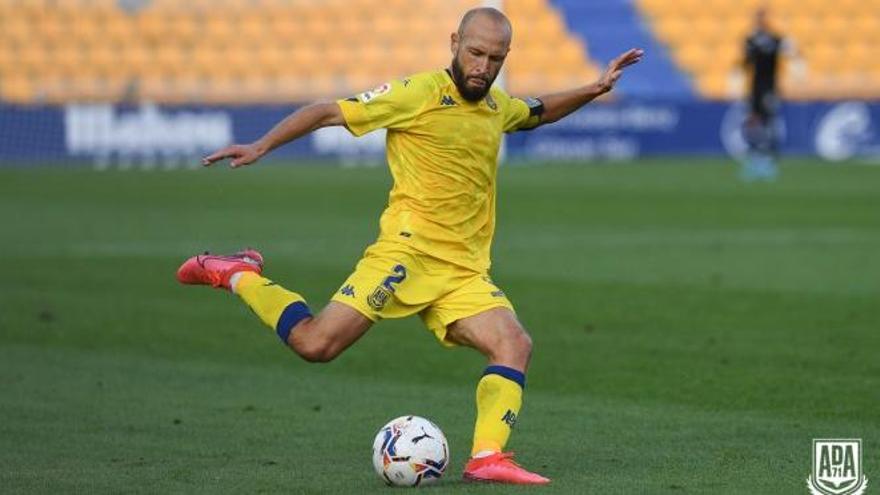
[741,8,796,181]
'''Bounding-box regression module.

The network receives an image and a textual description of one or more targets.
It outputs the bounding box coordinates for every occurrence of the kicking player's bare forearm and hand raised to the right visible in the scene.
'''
[538,48,645,125]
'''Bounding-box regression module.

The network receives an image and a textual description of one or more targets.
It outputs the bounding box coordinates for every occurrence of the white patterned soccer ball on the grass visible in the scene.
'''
[373,416,449,486]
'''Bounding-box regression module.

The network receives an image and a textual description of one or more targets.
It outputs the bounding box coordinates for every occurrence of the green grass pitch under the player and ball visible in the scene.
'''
[0,159,880,494]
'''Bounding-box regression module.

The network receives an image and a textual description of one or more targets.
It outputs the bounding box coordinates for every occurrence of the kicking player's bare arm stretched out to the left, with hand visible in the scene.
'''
[202,102,345,168]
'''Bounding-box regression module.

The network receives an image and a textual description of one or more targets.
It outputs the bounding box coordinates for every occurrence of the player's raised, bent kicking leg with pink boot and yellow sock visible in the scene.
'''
[177,250,373,362]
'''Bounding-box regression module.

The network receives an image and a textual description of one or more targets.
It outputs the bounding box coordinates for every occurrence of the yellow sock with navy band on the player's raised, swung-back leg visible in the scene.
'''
[233,272,312,344]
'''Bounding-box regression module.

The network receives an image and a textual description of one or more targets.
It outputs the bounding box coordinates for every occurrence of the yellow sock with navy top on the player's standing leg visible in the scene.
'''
[471,366,526,456]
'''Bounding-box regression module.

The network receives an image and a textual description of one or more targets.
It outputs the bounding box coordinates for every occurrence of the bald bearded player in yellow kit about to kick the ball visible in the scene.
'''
[177,8,642,484]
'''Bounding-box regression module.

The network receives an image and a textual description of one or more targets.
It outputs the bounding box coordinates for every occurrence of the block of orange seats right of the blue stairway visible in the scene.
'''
[638,0,880,99]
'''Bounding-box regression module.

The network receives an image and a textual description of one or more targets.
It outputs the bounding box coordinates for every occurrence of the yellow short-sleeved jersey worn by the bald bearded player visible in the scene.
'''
[338,70,540,272]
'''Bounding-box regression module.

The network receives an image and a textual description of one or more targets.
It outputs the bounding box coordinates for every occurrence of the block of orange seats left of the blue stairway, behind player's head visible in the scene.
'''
[0,0,598,103]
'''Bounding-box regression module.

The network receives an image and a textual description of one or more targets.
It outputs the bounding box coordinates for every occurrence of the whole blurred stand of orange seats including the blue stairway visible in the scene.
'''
[0,0,880,104]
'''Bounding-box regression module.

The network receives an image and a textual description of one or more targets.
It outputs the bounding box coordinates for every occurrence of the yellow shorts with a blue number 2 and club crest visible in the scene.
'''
[333,242,513,346]
